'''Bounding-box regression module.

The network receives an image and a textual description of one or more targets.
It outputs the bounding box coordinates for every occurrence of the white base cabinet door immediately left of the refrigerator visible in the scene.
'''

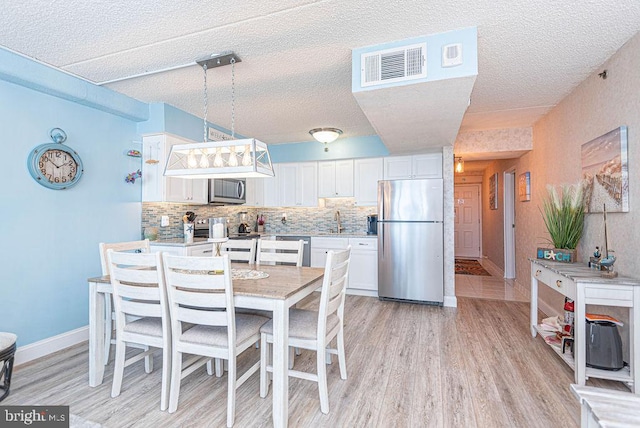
[347,238,378,297]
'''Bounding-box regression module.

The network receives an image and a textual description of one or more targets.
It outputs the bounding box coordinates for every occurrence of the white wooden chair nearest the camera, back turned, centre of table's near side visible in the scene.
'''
[163,253,267,427]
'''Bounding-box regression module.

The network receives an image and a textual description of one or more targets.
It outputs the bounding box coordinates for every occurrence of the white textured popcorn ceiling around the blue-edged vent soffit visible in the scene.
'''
[0,0,640,147]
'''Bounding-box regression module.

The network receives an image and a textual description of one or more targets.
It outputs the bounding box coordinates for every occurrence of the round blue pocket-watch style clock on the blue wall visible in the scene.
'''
[27,128,84,190]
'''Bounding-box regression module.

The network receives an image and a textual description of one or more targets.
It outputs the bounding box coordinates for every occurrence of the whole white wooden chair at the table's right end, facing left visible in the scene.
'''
[260,247,351,414]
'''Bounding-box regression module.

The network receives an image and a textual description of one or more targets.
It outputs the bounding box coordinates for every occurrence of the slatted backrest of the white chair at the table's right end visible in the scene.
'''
[318,246,351,340]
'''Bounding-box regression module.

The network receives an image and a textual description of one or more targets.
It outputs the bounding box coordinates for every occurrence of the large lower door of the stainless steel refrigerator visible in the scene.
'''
[378,222,444,304]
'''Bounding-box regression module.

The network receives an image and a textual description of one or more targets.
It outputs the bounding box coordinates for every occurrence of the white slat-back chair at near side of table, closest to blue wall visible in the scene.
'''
[107,250,171,410]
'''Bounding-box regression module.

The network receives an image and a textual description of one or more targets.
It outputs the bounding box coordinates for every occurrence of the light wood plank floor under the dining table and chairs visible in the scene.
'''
[2,296,626,427]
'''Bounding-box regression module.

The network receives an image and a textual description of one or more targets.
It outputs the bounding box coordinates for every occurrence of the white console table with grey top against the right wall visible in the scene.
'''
[529,258,640,394]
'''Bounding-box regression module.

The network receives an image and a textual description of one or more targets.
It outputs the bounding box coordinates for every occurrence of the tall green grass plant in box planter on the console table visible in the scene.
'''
[538,183,585,262]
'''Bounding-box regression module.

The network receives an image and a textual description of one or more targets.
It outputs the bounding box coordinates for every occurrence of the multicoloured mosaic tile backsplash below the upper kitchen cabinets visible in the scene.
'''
[142,198,376,239]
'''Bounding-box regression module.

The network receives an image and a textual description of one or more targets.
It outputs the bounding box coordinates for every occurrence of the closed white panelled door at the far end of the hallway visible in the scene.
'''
[453,184,480,258]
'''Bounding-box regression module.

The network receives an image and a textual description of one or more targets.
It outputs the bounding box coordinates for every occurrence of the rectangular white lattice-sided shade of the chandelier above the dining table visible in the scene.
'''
[164,138,274,178]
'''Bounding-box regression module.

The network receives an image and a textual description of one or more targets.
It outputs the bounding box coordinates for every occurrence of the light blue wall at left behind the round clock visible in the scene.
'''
[0,75,141,346]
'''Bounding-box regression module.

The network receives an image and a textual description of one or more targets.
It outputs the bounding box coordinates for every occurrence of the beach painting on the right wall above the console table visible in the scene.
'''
[582,126,629,213]
